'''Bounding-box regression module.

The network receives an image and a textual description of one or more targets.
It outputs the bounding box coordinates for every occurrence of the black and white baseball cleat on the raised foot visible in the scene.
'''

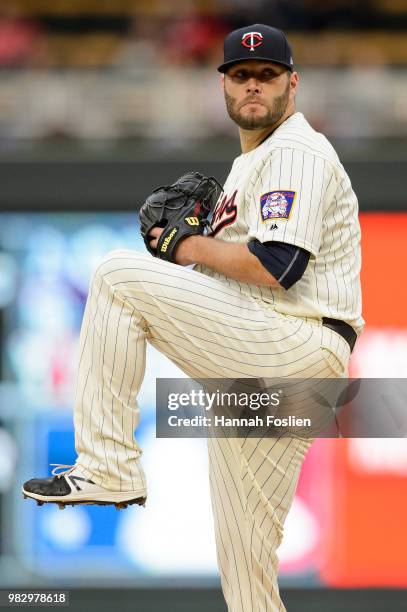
[22,463,147,510]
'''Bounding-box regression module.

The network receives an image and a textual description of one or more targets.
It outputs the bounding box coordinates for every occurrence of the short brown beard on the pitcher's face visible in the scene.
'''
[225,82,290,130]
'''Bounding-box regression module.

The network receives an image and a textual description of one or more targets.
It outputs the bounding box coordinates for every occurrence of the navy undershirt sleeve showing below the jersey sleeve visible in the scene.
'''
[247,240,310,289]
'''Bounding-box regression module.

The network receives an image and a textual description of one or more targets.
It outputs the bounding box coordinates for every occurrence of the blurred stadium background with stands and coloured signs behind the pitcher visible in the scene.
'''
[0,0,407,612]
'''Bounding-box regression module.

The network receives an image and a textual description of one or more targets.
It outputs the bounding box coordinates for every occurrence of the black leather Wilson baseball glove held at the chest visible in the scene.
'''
[140,172,222,262]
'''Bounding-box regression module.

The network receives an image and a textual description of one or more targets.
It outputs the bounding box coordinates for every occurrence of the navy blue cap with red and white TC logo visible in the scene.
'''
[218,23,294,72]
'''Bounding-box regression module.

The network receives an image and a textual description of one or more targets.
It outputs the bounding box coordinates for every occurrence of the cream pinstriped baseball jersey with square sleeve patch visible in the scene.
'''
[195,112,364,333]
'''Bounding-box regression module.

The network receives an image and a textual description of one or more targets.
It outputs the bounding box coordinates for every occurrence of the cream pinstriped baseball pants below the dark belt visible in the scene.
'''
[74,250,349,612]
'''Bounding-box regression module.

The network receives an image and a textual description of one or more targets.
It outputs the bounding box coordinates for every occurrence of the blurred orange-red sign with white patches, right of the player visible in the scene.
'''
[282,213,407,587]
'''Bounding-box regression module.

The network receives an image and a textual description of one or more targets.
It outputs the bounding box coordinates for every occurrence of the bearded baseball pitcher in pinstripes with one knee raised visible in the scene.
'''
[23,24,363,612]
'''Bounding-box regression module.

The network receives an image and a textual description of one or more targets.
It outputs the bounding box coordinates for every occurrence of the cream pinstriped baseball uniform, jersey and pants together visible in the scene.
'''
[75,113,363,612]
